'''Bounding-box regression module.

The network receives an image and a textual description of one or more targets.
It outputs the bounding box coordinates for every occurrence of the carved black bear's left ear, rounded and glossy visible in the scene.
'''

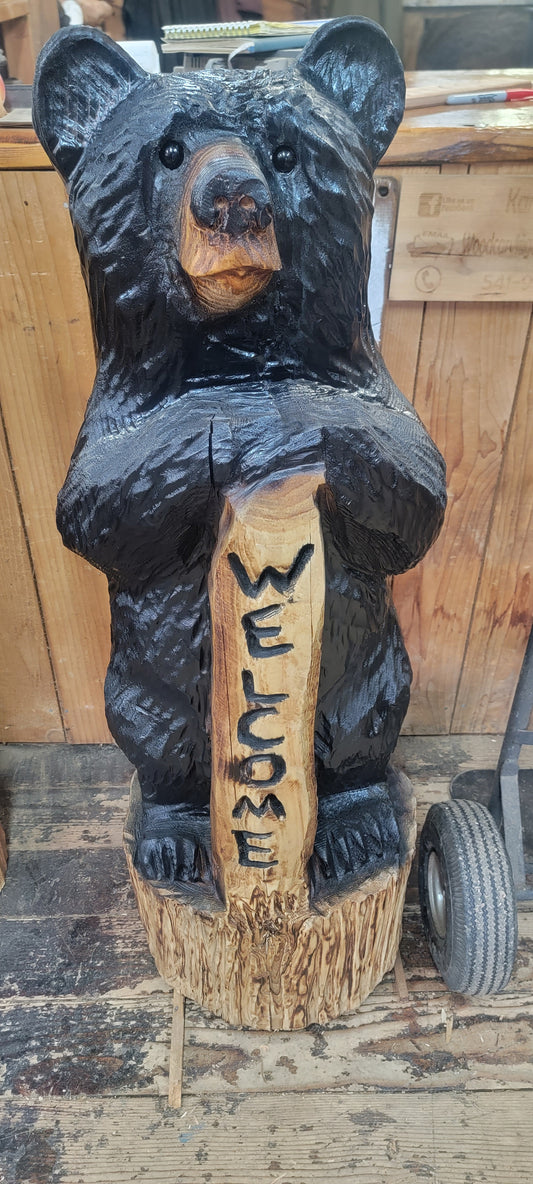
[33,25,147,181]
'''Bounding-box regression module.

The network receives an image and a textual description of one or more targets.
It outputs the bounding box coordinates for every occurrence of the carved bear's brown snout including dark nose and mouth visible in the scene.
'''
[180,140,282,315]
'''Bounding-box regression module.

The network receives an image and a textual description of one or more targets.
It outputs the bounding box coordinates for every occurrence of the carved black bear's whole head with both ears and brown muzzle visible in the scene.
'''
[34,18,404,400]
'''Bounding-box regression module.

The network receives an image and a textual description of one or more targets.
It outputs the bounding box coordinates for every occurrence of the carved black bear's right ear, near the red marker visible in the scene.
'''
[298,17,405,166]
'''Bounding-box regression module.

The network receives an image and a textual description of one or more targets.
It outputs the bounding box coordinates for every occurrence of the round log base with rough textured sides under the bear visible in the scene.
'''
[124,774,416,1031]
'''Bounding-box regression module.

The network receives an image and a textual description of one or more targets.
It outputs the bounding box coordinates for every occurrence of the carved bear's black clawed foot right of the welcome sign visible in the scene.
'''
[309,783,403,897]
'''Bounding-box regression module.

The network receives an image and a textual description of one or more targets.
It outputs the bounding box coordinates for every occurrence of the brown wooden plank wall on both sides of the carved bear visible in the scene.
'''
[0,163,533,742]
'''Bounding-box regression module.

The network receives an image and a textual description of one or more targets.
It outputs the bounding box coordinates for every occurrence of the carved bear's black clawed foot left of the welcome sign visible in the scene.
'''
[134,804,212,883]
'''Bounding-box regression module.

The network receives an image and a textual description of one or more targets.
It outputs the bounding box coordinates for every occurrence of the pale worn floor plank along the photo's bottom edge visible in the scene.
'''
[0,1092,533,1184]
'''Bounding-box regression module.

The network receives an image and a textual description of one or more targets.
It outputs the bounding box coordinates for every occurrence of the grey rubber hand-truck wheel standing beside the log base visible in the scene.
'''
[418,802,518,995]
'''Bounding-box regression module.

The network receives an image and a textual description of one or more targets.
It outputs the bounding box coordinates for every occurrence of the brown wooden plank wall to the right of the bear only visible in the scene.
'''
[384,163,533,735]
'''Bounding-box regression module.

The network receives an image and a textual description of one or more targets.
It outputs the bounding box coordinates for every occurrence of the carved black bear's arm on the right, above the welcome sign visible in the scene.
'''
[230,371,445,574]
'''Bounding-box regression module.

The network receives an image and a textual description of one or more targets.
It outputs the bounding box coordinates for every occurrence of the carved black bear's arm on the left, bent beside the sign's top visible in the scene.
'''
[57,400,225,578]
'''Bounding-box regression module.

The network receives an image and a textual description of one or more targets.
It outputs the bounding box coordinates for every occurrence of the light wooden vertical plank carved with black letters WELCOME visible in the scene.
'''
[210,471,325,906]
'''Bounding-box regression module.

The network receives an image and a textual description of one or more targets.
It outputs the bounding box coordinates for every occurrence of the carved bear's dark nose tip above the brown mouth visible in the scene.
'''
[191,162,272,238]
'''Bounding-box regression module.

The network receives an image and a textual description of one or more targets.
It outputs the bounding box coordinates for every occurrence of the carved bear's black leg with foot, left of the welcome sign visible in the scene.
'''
[105,554,211,882]
